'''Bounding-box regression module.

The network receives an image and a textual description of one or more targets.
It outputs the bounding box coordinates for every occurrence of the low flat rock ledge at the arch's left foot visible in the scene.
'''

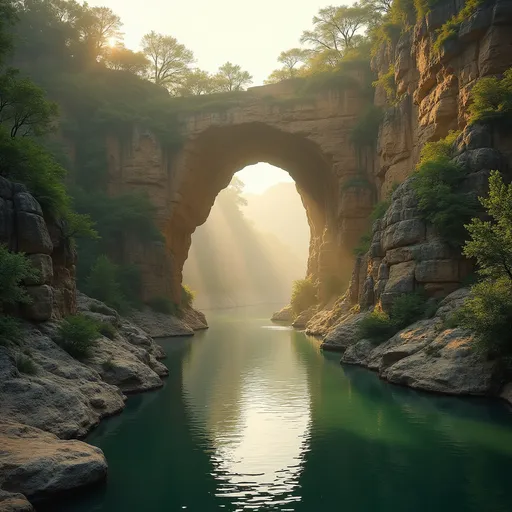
[130,308,208,338]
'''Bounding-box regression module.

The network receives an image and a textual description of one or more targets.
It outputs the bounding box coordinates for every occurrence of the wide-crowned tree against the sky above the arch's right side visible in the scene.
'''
[301,3,371,61]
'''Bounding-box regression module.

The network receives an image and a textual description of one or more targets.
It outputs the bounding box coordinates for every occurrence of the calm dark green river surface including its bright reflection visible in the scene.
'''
[48,308,512,512]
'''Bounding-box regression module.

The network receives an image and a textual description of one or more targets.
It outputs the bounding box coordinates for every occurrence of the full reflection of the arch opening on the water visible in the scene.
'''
[183,320,311,510]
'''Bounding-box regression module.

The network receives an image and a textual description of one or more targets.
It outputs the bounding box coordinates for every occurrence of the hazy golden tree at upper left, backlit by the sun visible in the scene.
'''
[77,4,123,60]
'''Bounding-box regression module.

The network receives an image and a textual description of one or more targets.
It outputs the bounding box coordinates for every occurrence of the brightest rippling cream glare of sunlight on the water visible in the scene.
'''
[214,370,310,510]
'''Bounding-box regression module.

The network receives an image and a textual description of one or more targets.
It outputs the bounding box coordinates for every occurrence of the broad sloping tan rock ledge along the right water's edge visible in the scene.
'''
[322,289,512,403]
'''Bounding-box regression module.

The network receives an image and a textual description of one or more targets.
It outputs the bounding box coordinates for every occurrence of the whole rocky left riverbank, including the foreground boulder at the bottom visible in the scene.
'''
[0,293,206,512]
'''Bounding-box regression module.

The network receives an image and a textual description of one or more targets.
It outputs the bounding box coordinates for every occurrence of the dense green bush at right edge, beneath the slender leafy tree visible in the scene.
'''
[459,277,512,358]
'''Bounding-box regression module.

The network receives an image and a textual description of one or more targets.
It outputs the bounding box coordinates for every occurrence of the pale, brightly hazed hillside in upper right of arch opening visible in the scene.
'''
[242,183,310,258]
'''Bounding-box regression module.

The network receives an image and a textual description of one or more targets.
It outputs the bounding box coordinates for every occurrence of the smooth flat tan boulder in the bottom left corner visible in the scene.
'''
[0,422,107,502]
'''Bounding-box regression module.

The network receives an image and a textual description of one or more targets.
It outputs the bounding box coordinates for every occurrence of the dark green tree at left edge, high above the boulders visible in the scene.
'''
[0,69,58,138]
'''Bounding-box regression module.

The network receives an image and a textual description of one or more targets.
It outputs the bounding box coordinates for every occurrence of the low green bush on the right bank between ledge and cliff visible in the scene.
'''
[358,292,428,344]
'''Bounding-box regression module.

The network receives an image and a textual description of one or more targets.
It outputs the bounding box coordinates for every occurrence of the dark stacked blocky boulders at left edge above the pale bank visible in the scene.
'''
[0,177,76,322]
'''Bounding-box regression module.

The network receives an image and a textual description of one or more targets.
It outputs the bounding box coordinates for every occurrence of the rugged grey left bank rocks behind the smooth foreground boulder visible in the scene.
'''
[0,294,168,439]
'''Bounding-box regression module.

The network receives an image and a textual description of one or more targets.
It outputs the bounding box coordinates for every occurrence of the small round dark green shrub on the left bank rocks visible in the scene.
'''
[57,315,100,359]
